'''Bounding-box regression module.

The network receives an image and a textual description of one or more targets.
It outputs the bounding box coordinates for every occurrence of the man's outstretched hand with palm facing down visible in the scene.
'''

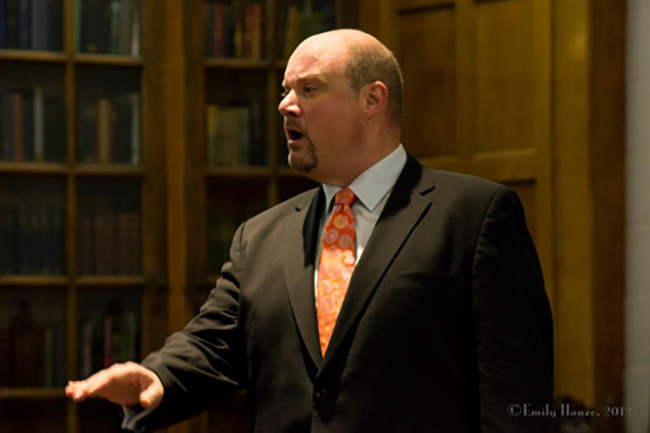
[65,362,164,409]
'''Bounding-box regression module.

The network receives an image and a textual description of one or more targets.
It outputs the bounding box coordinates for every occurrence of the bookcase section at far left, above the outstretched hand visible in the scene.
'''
[0,0,167,432]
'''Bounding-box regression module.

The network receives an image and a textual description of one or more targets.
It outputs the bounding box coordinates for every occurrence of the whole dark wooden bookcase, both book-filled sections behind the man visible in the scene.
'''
[0,0,357,433]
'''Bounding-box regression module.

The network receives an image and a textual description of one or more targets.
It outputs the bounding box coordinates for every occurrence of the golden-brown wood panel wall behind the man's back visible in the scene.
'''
[360,0,625,432]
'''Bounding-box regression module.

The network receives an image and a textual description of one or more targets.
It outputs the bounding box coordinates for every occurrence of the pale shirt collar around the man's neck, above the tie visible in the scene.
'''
[323,143,406,212]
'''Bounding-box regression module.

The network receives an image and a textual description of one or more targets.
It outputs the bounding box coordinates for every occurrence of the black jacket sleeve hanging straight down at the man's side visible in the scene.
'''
[472,188,553,433]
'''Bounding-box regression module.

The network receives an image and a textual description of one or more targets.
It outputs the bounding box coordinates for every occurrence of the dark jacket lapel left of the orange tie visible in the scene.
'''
[284,188,325,366]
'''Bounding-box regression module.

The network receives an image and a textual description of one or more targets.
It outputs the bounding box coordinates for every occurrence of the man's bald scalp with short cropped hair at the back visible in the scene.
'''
[292,29,404,126]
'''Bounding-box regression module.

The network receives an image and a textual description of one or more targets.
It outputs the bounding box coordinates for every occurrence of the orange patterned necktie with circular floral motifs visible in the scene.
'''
[316,188,356,355]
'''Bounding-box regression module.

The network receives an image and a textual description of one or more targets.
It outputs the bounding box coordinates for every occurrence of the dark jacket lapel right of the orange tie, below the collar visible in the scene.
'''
[322,156,434,368]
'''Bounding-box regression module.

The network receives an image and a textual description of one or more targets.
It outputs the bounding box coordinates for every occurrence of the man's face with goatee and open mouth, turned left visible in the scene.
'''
[278,40,362,184]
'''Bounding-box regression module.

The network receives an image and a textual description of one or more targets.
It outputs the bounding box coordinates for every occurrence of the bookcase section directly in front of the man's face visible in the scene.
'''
[185,0,358,432]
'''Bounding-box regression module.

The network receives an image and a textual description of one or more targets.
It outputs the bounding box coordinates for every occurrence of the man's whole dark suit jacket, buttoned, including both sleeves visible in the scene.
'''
[137,157,553,433]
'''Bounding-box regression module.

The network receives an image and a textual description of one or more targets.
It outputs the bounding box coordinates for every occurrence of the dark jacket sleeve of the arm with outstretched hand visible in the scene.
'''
[136,221,246,431]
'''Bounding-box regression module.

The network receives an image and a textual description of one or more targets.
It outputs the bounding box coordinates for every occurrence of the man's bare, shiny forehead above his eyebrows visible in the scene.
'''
[283,45,345,84]
